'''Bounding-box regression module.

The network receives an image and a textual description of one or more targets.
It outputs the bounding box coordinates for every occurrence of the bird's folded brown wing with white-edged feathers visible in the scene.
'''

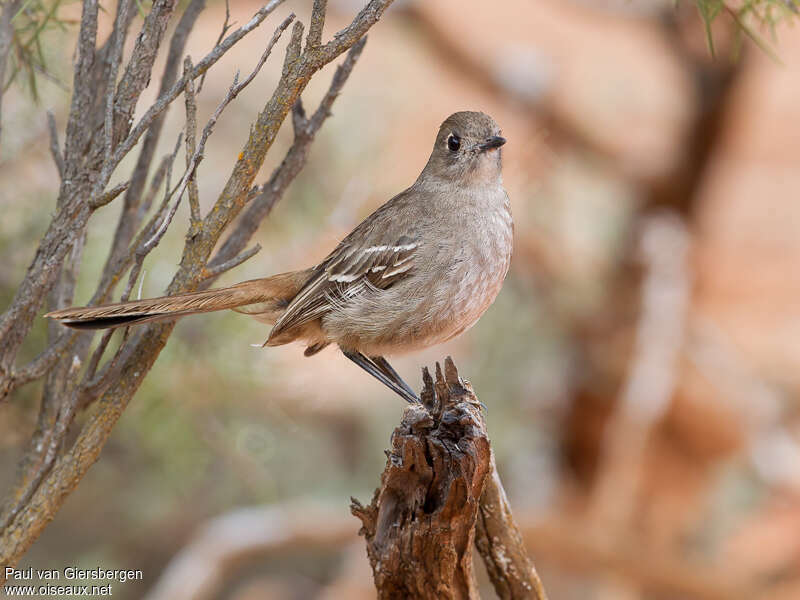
[268,235,419,343]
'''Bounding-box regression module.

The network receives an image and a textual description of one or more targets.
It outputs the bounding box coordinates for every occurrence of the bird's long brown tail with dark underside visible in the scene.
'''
[45,271,308,329]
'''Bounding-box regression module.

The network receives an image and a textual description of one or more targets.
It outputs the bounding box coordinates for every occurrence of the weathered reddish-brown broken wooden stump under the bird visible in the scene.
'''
[351,357,545,600]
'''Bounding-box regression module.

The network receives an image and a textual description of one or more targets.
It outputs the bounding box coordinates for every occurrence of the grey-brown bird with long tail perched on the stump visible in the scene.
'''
[45,112,513,402]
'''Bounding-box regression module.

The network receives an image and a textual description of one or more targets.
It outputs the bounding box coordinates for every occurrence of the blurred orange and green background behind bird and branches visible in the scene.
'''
[0,0,800,600]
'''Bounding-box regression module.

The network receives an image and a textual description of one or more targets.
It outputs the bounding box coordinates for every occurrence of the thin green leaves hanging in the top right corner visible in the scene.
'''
[694,0,800,62]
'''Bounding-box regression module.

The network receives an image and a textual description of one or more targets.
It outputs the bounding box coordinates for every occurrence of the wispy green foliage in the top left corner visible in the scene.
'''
[0,0,71,101]
